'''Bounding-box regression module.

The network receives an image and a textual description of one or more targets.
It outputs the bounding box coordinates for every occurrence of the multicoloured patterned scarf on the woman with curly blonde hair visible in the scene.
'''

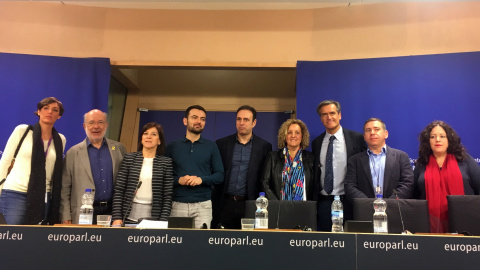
[281,147,305,201]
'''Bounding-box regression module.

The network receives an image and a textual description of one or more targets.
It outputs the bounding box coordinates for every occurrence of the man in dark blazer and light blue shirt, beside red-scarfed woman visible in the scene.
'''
[345,118,413,201]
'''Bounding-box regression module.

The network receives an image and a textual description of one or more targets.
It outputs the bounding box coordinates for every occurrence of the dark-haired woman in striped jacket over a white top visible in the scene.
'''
[112,122,173,225]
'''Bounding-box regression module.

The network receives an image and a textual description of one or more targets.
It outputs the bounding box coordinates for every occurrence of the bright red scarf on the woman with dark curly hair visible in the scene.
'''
[425,154,465,233]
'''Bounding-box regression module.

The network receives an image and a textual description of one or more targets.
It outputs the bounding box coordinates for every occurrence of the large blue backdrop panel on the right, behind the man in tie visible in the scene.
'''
[297,52,480,161]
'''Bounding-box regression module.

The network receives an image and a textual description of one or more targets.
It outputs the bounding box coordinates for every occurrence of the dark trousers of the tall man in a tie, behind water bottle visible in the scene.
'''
[317,195,353,232]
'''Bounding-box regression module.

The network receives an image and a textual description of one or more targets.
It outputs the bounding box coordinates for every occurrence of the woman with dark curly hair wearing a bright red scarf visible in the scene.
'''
[414,121,480,233]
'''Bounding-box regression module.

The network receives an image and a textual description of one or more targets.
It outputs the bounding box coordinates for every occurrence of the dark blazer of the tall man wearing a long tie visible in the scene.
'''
[312,127,367,200]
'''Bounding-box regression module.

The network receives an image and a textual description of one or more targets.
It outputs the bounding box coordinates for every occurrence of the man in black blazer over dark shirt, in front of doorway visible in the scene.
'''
[212,105,272,229]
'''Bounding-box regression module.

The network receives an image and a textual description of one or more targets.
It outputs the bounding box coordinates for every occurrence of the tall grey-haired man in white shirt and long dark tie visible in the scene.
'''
[312,100,367,231]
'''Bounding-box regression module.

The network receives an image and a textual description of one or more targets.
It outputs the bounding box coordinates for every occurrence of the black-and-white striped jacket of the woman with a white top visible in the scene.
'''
[112,151,173,221]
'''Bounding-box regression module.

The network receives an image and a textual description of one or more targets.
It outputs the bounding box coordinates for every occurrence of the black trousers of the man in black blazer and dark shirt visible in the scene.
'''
[220,197,245,229]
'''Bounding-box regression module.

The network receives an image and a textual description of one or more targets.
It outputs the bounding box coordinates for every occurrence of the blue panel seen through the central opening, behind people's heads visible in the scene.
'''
[140,111,290,149]
